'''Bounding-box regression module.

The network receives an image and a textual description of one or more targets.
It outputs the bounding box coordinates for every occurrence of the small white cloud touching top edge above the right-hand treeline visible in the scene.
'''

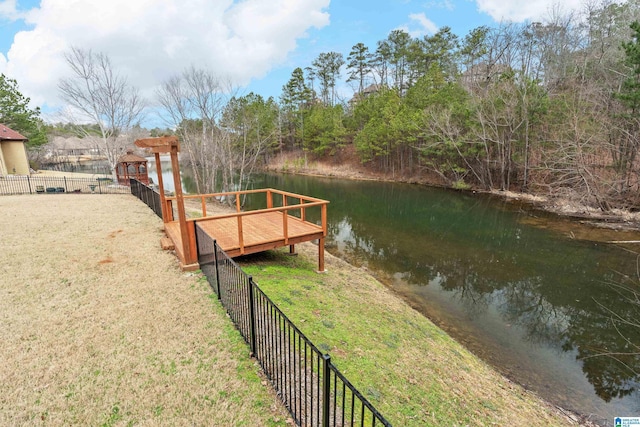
[475,0,585,22]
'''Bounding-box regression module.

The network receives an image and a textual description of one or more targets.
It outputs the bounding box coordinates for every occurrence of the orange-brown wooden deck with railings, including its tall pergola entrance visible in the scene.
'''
[135,136,329,272]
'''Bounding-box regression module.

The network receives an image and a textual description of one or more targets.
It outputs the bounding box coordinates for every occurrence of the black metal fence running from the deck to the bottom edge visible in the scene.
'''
[196,224,391,427]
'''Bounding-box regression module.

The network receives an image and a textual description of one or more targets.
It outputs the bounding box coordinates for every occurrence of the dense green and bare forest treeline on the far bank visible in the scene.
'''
[281,1,640,209]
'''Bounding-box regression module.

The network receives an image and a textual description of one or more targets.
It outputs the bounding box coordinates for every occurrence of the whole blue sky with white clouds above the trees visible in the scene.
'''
[0,0,608,127]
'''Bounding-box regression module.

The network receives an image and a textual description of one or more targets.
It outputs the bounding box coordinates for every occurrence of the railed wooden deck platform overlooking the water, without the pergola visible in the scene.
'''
[160,189,328,271]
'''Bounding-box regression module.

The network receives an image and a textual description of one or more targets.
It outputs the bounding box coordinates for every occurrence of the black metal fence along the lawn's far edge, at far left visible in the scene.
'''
[0,175,131,196]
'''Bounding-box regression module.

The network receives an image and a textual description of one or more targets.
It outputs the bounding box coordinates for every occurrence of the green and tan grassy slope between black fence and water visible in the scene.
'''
[241,244,570,426]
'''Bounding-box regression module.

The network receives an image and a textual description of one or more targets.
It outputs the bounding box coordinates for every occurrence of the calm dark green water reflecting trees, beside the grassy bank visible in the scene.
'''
[246,175,640,425]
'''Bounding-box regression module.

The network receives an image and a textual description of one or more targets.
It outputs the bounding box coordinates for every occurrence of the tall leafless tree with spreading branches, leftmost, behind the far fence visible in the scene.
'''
[58,47,145,173]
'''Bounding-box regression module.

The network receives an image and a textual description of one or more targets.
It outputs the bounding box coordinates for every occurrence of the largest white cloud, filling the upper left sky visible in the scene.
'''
[0,0,329,113]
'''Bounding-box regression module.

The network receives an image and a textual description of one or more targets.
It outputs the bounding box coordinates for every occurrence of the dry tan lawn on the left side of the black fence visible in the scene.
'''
[0,194,287,426]
